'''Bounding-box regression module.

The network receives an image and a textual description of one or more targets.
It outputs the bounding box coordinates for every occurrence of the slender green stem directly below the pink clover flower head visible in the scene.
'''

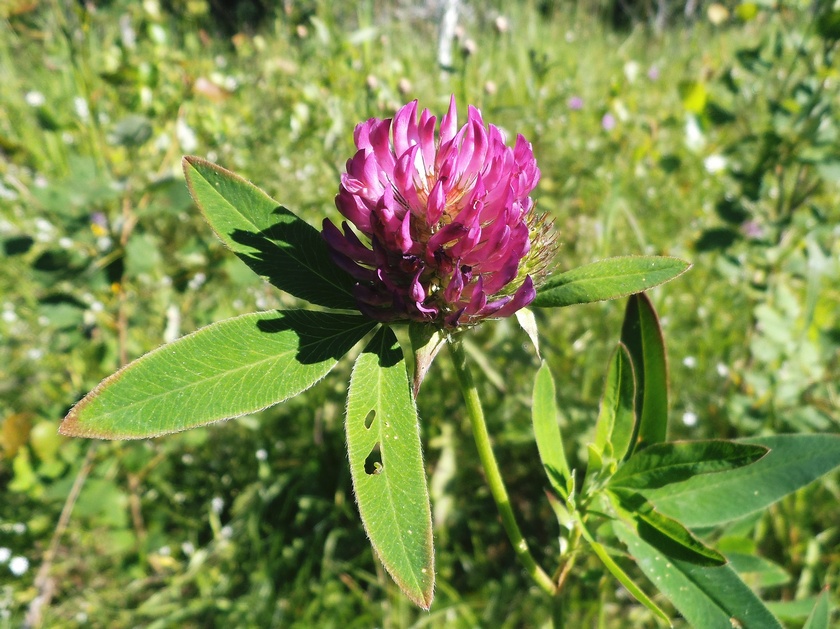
[449,338,557,596]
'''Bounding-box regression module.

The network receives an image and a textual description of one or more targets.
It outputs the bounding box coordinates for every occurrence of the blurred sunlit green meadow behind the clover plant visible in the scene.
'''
[0,0,840,628]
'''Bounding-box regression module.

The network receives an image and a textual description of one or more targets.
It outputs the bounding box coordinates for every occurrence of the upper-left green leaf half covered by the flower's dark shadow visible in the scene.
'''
[183,157,357,310]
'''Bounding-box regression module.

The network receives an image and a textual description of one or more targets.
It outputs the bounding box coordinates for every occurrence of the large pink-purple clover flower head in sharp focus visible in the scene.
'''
[323,97,553,329]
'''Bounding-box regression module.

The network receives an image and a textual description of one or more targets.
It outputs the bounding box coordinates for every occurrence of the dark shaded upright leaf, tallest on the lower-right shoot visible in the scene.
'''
[621,293,668,450]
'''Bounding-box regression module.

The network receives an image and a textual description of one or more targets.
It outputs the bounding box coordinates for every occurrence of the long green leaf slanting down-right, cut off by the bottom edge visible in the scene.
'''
[613,521,782,629]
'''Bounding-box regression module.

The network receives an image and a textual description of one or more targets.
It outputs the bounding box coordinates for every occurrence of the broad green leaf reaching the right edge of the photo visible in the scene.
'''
[643,434,840,527]
